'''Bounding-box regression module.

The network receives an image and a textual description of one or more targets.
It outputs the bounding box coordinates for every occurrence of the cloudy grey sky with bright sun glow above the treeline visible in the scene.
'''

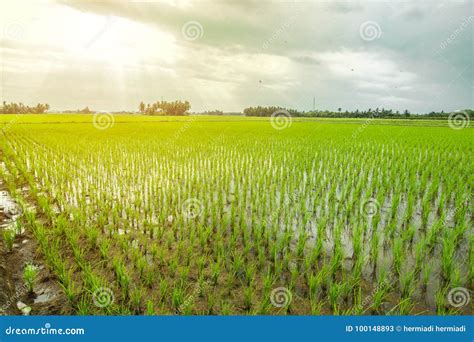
[0,0,474,113]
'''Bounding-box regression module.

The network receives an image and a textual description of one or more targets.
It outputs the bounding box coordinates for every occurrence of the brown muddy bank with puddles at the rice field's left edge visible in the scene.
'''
[0,180,71,315]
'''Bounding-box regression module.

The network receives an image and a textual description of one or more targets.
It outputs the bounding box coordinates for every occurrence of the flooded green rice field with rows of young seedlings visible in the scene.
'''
[0,115,474,315]
